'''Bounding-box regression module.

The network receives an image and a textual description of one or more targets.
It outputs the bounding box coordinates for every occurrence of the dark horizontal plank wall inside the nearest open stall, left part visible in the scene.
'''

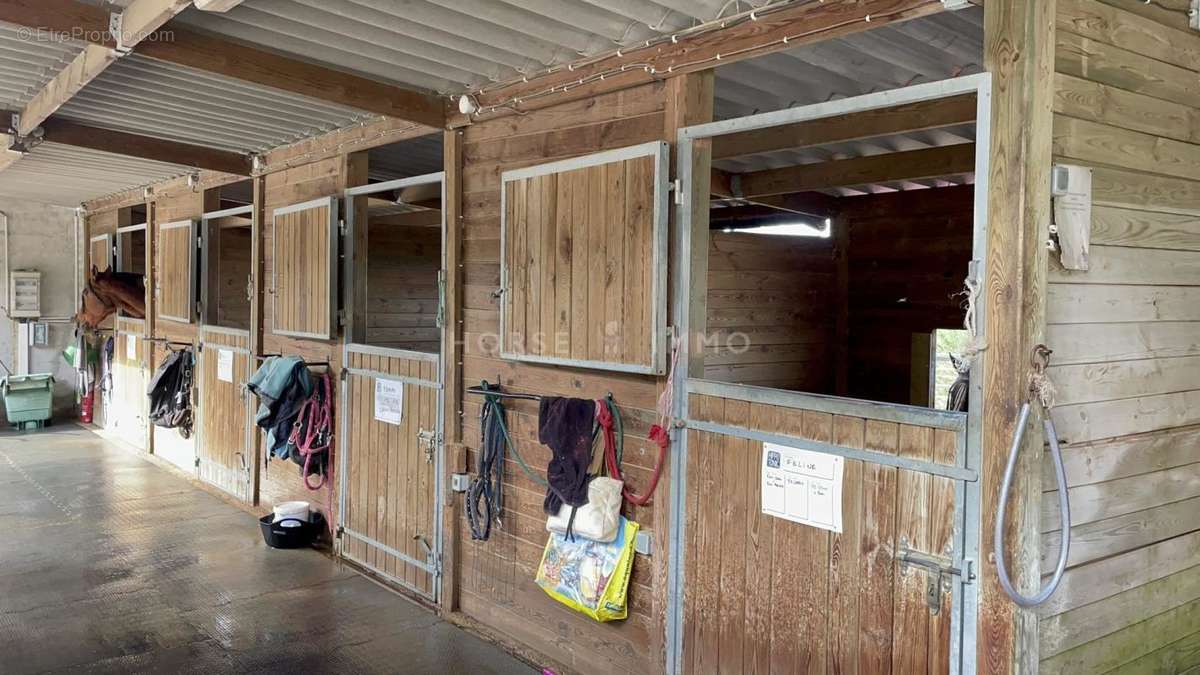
[704,232,836,394]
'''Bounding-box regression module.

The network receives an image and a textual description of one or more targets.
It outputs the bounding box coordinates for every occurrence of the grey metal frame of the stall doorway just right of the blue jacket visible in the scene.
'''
[337,171,450,603]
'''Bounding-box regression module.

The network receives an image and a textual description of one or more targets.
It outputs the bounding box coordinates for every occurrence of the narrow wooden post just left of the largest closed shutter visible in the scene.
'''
[436,130,467,614]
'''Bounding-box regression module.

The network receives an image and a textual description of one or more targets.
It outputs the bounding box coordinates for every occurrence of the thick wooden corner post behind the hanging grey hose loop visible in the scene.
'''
[976,0,1056,673]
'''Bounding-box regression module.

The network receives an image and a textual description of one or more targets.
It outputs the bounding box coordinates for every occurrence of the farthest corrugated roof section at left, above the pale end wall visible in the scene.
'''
[0,143,191,207]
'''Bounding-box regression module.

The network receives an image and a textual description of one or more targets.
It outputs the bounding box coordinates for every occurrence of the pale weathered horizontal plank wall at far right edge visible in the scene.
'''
[1040,0,1200,673]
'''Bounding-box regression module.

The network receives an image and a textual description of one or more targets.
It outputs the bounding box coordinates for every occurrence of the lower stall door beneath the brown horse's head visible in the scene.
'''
[110,317,149,450]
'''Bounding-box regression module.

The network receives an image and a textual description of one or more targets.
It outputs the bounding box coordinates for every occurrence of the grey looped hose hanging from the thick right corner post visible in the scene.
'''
[992,345,1070,608]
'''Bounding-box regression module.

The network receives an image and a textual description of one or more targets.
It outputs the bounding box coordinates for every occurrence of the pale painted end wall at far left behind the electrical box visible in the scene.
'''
[0,197,82,423]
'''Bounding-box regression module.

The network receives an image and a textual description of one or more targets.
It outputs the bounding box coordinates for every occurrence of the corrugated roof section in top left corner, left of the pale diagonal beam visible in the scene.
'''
[0,23,83,110]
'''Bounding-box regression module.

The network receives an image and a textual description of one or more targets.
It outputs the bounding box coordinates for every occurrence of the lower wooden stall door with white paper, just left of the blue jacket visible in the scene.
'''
[196,327,254,501]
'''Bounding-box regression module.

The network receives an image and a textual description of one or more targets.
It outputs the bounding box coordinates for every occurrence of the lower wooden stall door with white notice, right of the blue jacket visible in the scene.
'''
[340,346,442,601]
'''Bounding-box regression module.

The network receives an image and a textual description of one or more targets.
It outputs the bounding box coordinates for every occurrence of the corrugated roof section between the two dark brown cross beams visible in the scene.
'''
[58,53,373,153]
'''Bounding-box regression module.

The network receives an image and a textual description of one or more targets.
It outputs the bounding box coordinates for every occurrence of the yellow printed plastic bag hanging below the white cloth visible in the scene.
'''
[536,516,638,621]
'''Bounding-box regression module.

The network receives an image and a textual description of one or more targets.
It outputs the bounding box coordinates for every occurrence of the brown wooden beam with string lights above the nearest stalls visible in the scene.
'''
[463,0,943,127]
